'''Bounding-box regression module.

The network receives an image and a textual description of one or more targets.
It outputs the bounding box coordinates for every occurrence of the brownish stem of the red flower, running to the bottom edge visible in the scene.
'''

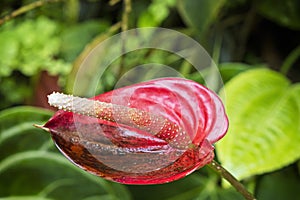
[208,160,256,200]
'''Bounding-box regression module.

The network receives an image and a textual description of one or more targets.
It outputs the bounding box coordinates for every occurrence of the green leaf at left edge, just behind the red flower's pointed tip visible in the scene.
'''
[0,106,52,160]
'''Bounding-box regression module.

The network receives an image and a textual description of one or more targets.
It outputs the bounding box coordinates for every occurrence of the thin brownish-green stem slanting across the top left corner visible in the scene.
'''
[0,0,61,25]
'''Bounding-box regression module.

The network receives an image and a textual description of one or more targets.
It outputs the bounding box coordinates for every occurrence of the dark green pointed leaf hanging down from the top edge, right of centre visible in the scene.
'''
[178,0,226,34]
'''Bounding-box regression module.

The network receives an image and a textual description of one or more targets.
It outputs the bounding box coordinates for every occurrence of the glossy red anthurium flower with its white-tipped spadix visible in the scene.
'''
[39,78,228,184]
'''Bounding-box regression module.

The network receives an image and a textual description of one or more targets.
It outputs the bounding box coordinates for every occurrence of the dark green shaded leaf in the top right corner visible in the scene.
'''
[256,0,300,30]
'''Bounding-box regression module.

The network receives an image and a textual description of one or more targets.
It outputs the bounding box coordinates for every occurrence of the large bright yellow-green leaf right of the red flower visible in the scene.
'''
[217,69,300,179]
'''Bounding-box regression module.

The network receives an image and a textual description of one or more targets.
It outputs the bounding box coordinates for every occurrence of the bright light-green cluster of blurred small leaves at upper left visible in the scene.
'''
[0,16,71,77]
